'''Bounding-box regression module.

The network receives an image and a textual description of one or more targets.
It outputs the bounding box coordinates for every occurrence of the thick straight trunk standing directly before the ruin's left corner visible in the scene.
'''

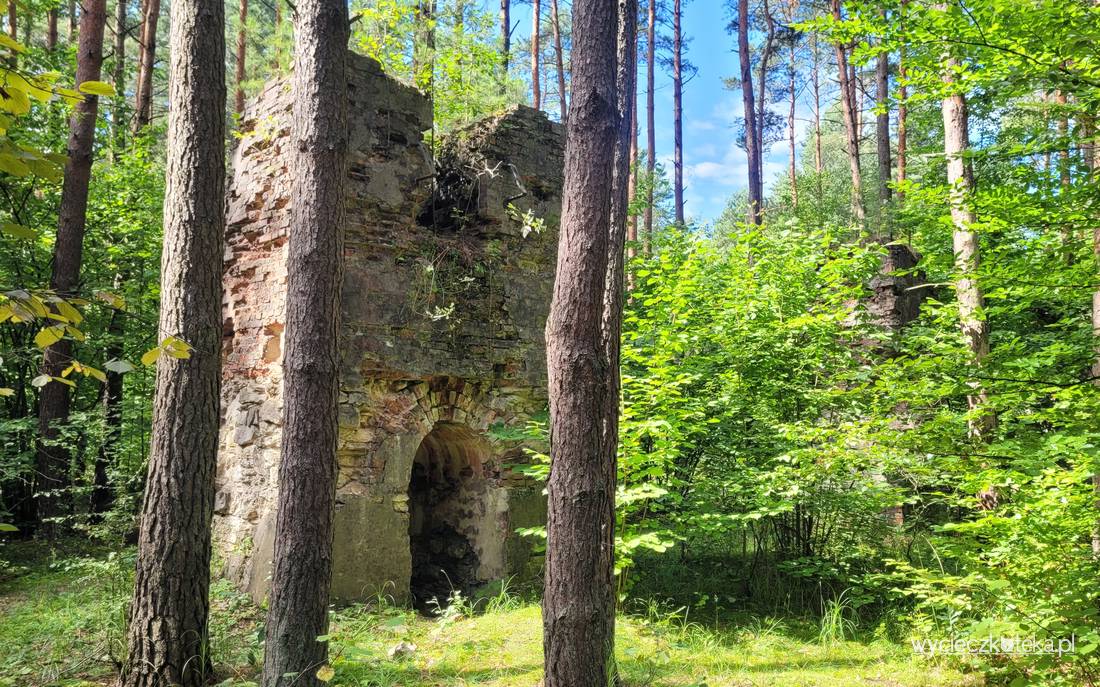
[263,0,349,687]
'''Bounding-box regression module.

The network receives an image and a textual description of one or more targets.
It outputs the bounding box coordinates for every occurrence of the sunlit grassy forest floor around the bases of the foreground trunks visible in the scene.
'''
[0,546,981,687]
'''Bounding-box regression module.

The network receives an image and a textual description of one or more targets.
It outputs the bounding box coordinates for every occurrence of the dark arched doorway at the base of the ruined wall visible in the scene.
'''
[409,422,488,610]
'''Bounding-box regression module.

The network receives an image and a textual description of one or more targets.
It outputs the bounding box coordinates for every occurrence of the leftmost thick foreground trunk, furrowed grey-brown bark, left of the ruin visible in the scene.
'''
[118,0,226,687]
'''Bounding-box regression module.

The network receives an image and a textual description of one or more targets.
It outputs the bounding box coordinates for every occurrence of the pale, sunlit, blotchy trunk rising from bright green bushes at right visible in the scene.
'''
[939,40,996,440]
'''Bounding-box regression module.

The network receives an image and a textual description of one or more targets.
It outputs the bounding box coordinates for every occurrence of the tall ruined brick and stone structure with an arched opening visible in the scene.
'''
[215,55,564,603]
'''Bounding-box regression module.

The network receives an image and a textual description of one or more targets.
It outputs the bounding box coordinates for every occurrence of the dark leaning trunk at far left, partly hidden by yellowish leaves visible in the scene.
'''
[35,0,107,539]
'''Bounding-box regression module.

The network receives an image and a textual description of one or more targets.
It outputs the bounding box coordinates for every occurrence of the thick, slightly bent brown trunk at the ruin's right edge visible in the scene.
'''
[542,0,619,687]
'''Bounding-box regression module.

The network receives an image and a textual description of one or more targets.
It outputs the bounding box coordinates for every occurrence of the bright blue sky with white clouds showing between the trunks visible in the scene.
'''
[503,0,807,224]
